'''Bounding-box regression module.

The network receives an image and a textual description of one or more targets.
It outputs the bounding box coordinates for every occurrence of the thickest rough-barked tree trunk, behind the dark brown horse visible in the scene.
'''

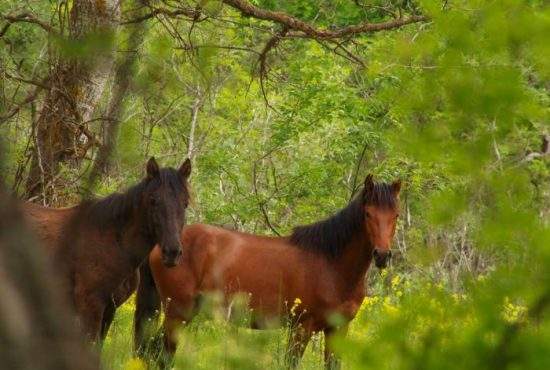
[26,0,120,204]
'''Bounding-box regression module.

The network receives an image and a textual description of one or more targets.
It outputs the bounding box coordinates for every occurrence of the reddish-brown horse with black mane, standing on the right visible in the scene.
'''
[136,175,401,367]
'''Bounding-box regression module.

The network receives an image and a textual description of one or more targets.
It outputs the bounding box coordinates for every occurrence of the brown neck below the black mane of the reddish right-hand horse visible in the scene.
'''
[333,233,372,288]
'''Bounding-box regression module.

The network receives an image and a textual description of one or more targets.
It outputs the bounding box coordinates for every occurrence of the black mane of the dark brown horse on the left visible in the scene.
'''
[80,168,187,229]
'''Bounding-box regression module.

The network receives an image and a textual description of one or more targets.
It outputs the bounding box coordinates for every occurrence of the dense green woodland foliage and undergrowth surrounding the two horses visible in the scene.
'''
[0,0,550,369]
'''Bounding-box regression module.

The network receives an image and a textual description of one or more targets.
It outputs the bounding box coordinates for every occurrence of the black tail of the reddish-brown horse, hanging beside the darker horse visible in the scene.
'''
[134,259,162,357]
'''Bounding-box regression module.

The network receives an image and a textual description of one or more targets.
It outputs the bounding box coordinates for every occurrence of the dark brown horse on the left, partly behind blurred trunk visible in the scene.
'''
[22,158,191,341]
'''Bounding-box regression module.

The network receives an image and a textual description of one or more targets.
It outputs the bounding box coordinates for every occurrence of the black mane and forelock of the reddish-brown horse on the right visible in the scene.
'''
[290,183,397,258]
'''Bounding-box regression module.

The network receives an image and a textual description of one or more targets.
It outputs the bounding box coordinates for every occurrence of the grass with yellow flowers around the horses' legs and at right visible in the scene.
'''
[102,270,516,370]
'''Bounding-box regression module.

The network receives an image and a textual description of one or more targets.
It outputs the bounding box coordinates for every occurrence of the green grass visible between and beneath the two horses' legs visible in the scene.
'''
[102,299,330,370]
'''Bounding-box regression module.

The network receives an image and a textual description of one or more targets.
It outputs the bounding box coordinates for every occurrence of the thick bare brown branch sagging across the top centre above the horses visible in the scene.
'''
[223,0,429,40]
